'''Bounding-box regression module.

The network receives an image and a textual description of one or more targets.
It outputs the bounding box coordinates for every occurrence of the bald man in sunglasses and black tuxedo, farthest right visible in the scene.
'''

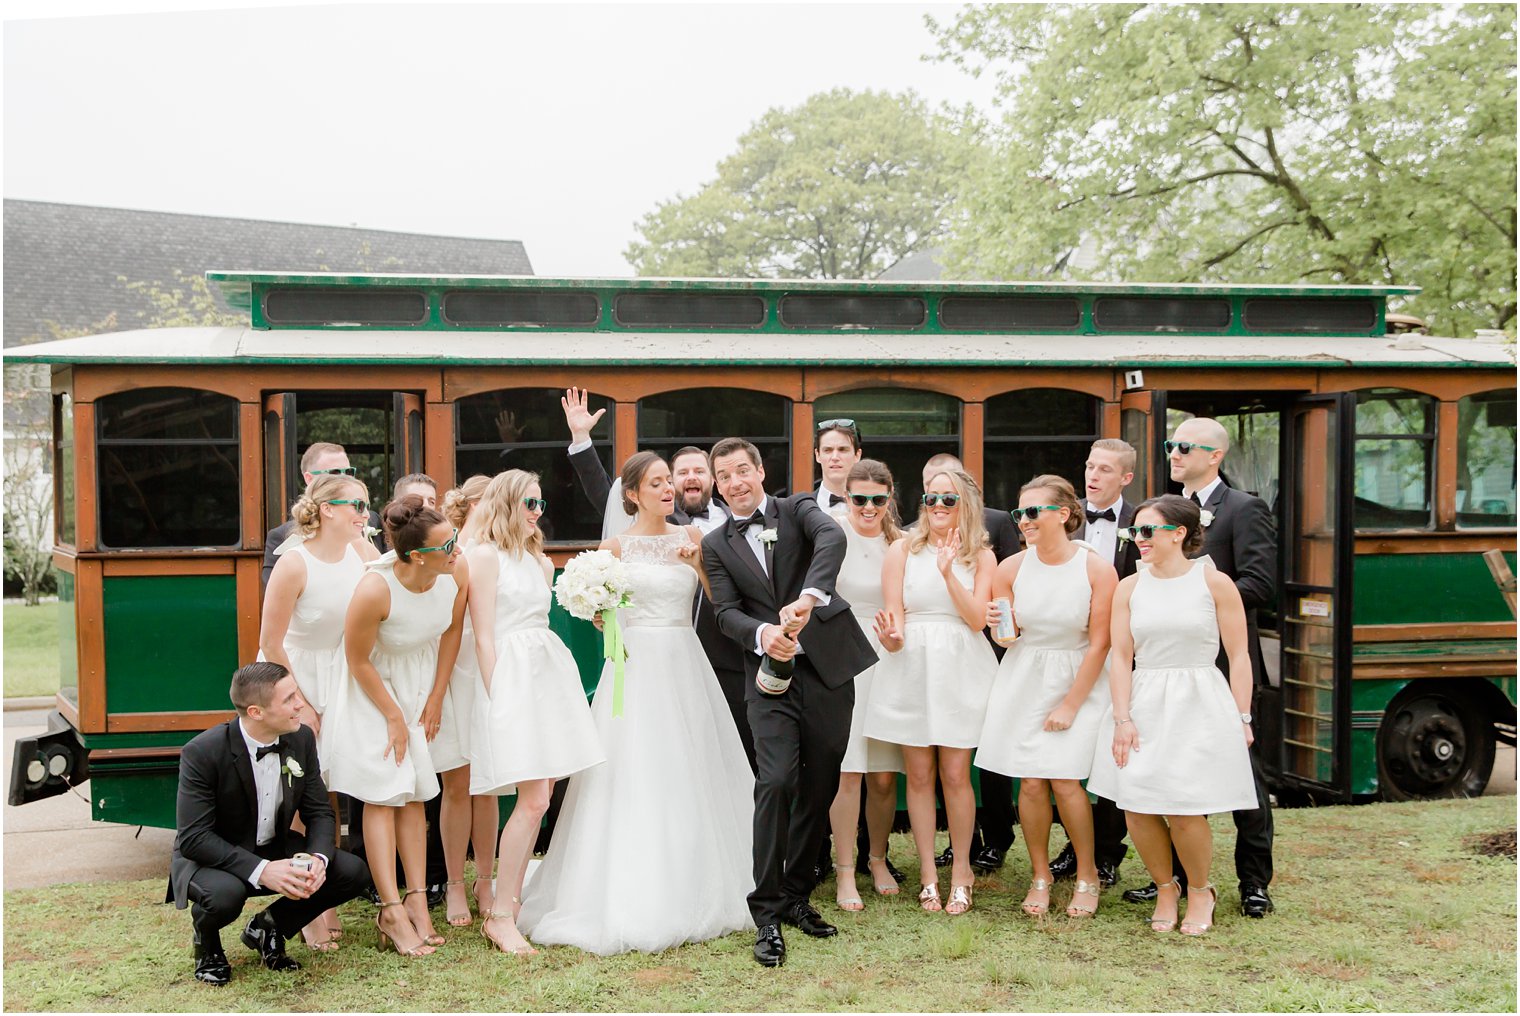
[1125,417,1277,917]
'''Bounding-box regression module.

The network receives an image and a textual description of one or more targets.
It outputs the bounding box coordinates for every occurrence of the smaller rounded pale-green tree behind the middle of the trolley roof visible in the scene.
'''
[623,88,977,278]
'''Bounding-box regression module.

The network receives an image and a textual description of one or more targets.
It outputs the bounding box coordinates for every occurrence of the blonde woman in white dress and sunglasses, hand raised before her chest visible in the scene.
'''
[865,468,997,914]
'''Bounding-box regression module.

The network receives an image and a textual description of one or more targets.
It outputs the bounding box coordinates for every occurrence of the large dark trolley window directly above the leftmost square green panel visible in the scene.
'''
[96,388,242,548]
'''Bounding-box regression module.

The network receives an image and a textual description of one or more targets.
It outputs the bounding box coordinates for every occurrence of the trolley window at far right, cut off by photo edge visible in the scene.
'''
[1456,388,1515,528]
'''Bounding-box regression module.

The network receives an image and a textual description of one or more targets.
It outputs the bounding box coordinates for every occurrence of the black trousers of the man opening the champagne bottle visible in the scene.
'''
[748,656,854,926]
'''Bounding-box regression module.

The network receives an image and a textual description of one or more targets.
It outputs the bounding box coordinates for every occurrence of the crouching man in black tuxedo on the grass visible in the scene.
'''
[164,663,369,984]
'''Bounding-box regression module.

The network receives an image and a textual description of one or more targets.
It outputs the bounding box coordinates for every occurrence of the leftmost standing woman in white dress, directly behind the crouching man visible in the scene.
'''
[258,473,380,952]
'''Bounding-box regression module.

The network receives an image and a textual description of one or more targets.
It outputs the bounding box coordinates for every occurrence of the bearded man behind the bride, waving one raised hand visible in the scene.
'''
[556,388,753,769]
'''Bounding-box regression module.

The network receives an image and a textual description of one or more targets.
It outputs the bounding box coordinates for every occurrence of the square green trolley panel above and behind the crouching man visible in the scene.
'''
[103,575,237,713]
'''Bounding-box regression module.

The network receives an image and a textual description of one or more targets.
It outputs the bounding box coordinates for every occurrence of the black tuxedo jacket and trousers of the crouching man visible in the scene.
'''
[164,716,369,940]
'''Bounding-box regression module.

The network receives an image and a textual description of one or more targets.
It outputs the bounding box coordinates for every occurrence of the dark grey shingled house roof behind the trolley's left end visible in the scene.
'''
[5,198,534,347]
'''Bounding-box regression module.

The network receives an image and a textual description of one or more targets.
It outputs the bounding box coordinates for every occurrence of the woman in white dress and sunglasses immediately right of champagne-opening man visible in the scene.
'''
[828,459,903,911]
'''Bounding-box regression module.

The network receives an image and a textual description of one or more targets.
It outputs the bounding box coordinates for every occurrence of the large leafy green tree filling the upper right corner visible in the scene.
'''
[930,5,1515,335]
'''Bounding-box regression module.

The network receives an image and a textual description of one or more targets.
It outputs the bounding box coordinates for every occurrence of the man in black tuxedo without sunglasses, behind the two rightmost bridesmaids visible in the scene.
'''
[1050,438,1140,887]
